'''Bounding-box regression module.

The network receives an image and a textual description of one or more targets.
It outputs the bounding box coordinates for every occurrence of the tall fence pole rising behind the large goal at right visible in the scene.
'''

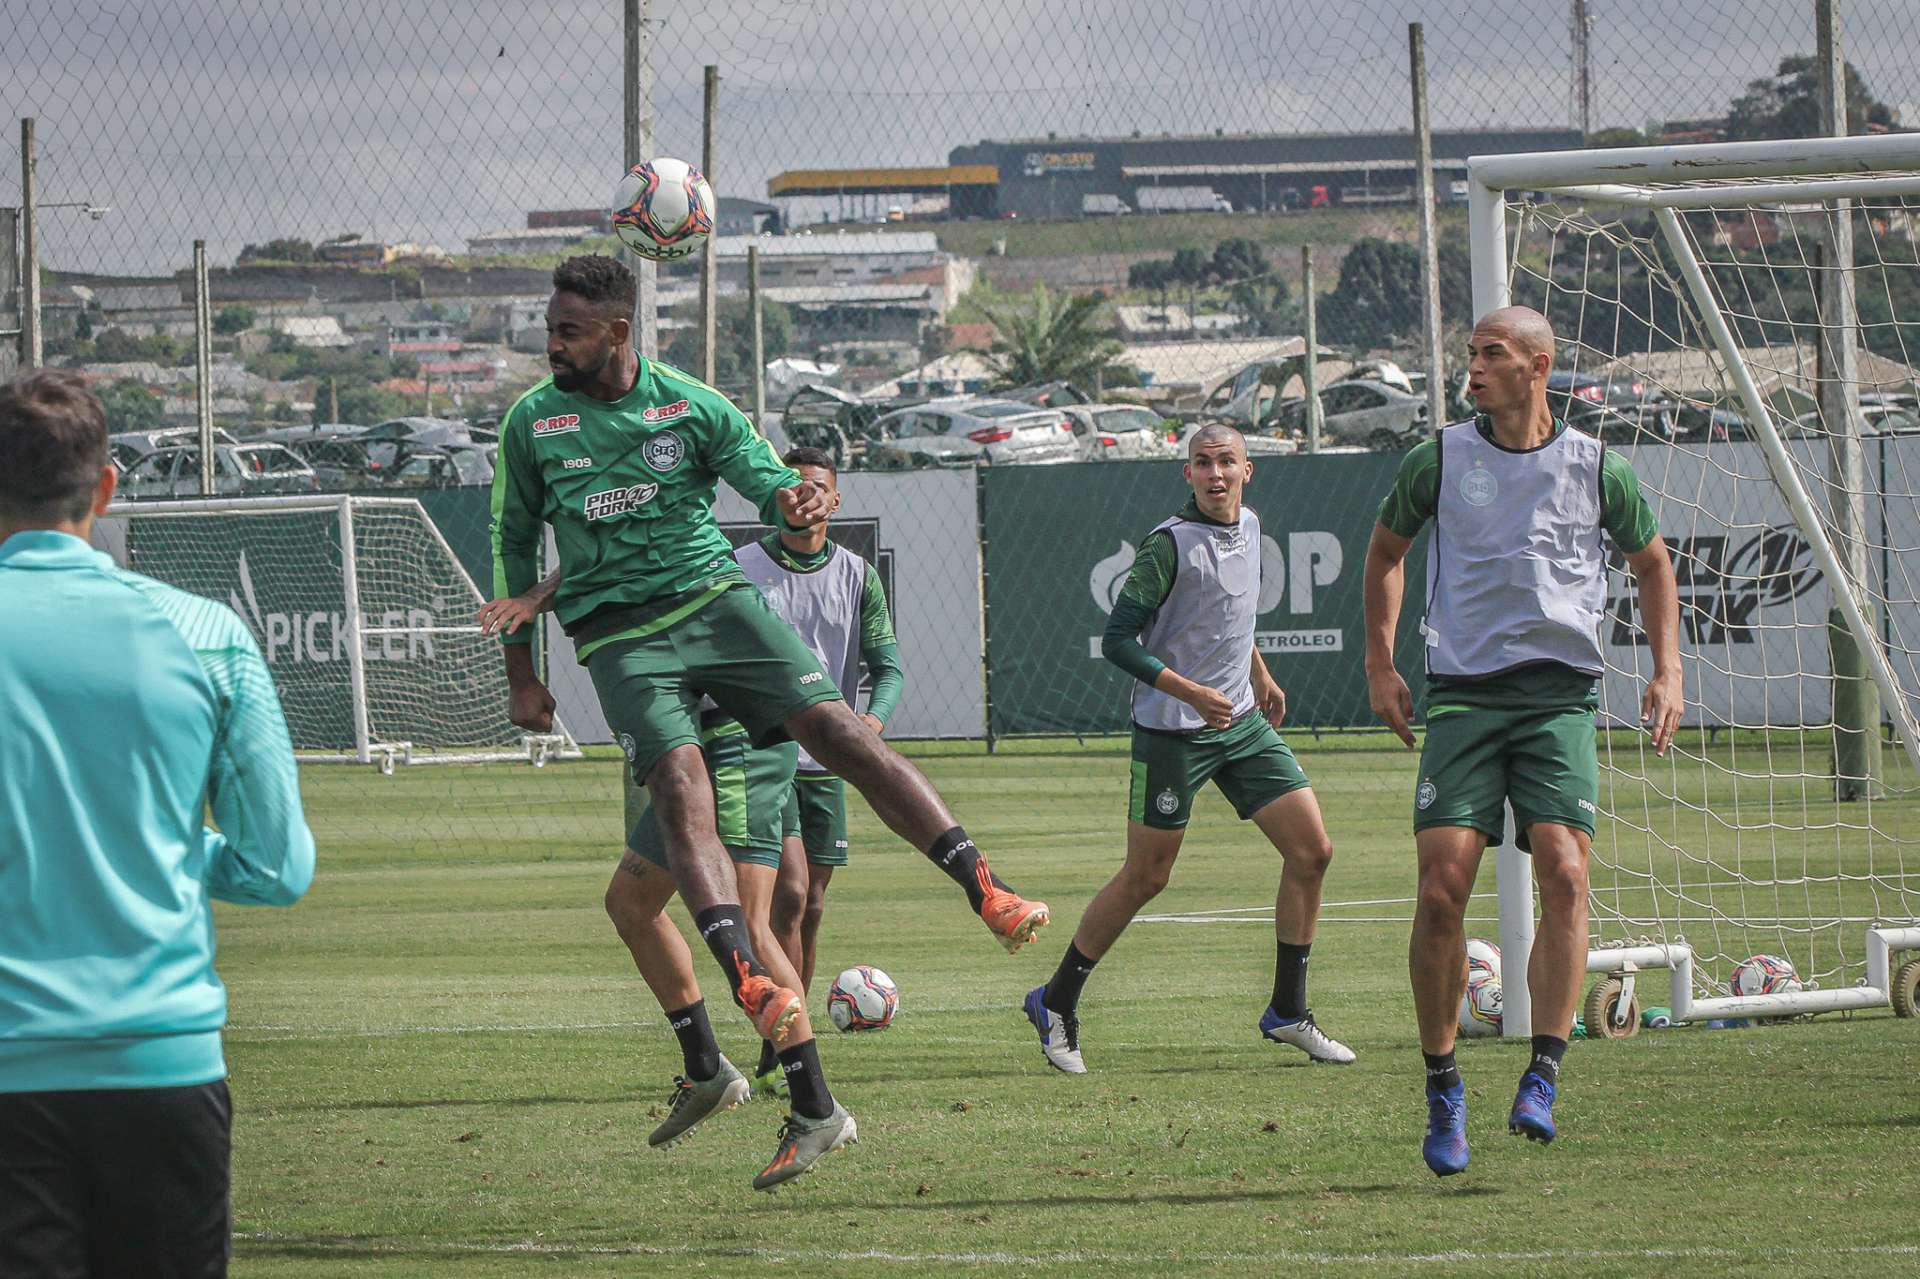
[1814,0,1884,801]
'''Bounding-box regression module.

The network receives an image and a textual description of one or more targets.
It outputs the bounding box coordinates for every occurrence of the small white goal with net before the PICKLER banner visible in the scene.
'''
[100,497,580,768]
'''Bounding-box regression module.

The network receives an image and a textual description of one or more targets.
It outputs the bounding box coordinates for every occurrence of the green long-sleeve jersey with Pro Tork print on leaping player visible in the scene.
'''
[493,359,801,643]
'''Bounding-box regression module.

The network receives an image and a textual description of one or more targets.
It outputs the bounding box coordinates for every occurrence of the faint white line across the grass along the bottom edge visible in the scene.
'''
[234,1231,1920,1266]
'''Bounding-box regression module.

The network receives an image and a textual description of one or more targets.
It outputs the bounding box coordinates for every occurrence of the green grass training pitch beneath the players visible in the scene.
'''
[219,736,1920,1277]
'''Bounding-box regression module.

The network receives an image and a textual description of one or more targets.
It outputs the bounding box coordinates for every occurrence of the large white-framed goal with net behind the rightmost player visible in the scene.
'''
[1469,134,1920,1035]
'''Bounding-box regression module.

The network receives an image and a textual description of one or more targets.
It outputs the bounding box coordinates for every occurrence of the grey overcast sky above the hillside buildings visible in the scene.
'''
[0,0,1920,273]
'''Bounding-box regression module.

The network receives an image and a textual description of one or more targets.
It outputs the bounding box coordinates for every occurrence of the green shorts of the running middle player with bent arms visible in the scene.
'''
[1127,711,1308,830]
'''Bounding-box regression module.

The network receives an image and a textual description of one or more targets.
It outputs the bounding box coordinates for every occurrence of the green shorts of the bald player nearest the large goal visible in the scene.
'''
[1413,705,1599,849]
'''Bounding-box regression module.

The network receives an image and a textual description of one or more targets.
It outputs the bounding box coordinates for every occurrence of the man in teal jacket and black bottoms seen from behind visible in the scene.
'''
[0,362,313,1275]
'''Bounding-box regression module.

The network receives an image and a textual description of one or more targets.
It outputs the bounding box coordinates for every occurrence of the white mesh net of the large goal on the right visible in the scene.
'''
[1509,182,1920,995]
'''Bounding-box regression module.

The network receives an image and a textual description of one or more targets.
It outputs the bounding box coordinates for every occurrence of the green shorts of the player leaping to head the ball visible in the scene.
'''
[588,586,841,782]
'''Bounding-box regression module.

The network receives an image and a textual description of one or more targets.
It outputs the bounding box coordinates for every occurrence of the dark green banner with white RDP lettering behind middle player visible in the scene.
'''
[979,453,1427,737]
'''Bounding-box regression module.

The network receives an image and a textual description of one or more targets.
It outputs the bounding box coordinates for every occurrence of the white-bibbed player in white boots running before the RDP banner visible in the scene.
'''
[1025,426,1354,1075]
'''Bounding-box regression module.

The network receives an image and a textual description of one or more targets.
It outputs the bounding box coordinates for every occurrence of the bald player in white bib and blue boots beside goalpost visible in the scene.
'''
[1365,307,1682,1177]
